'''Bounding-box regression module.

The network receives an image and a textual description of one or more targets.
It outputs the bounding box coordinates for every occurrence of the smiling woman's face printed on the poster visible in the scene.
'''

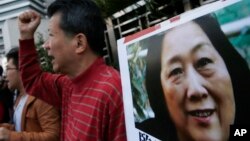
[161,22,235,141]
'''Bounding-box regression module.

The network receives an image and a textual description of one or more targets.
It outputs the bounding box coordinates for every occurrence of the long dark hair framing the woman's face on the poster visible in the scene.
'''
[142,14,250,140]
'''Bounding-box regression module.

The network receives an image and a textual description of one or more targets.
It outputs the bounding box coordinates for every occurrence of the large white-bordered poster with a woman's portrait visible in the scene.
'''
[118,0,250,141]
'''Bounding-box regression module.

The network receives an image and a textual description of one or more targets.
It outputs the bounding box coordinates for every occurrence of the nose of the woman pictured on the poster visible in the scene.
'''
[187,68,208,101]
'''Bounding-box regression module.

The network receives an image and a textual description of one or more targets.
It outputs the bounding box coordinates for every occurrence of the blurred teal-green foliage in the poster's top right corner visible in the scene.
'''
[215,0,250,68]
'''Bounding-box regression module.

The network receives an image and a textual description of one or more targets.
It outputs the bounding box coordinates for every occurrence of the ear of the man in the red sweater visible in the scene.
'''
[75,33,87,53]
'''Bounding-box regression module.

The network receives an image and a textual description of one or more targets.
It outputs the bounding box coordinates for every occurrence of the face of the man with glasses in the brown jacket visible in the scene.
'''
[6,58,21,90]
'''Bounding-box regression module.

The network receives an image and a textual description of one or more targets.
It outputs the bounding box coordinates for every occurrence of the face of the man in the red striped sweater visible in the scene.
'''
[44,13,76,74]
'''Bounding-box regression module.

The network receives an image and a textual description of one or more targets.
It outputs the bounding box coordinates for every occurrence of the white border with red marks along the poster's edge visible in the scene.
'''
[117,0,246,141]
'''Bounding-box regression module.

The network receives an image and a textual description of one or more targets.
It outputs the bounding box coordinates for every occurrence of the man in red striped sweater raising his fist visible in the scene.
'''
[18,0,126,141]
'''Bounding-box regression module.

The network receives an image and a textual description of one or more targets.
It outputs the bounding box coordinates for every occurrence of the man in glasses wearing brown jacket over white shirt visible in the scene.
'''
[0,48,60,141]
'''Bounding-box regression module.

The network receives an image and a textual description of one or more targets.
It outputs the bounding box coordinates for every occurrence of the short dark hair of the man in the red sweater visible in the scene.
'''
[48,0,105,55]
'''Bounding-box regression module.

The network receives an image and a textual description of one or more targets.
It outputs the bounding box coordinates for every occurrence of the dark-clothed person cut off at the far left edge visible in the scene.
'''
[0,66,13,123]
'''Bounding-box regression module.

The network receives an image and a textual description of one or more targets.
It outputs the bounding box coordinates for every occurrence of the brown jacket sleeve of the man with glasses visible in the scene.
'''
[9,100,60,141]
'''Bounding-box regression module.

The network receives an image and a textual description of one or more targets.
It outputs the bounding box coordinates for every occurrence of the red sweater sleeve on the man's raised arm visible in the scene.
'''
[19,39,64,108]
